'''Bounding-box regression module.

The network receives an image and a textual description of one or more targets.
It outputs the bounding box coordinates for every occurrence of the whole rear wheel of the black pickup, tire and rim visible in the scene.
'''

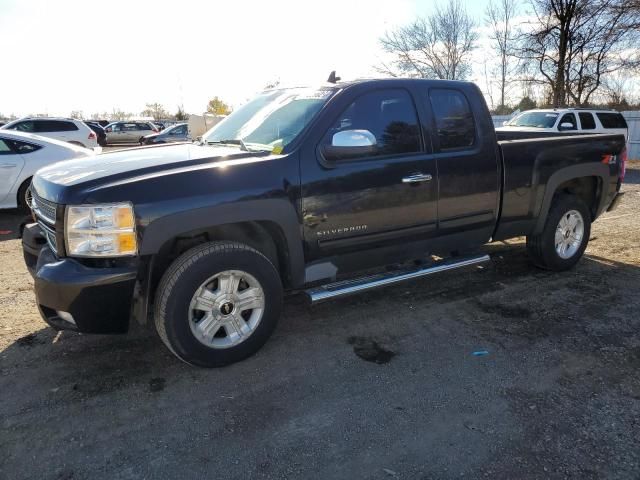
[527,194,591,271]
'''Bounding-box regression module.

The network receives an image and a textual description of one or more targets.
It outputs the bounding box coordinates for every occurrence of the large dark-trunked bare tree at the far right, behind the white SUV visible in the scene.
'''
[519,0,640,106]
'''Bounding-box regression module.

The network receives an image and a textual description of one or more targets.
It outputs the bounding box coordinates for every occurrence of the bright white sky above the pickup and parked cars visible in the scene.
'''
[0,0,496,115]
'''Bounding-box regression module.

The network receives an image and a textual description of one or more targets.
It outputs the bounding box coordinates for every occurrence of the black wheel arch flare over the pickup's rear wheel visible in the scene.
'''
[533,163,610,234]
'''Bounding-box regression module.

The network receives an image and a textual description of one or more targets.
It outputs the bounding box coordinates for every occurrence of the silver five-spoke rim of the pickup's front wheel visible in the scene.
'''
[189,270,264,349]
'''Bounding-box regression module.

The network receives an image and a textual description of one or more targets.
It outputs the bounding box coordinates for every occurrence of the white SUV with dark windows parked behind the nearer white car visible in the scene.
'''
[0,117,98,148]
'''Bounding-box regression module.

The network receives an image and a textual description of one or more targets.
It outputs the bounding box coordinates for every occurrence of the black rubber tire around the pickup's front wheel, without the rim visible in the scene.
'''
[154,241,283,367]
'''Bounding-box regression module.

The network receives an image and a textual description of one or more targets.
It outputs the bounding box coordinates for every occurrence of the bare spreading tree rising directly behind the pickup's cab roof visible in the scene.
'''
[377,0,478,80]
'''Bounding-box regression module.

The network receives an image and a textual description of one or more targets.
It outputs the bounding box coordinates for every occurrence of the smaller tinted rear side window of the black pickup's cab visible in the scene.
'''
[429,88,476,151]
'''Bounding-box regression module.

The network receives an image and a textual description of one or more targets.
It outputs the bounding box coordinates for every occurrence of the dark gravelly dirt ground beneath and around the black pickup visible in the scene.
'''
[0,163,640,479]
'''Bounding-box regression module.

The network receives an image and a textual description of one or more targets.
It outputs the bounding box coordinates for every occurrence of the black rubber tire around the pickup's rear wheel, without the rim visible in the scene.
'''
[527,194,591,272]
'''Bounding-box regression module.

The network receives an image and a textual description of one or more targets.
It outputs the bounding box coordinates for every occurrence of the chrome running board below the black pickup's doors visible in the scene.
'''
[305,255,489,303]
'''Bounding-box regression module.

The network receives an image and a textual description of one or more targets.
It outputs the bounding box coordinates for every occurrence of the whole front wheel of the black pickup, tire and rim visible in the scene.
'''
[155,242,283,367]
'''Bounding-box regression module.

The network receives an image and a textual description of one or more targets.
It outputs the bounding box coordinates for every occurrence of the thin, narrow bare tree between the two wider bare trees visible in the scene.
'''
[485,0,518,113]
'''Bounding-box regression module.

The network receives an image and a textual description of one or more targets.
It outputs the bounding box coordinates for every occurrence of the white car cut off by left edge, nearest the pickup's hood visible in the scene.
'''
[0,129,95,208]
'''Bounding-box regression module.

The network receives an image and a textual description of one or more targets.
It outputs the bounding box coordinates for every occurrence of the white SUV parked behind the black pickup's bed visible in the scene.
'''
[496,108,629,140]
